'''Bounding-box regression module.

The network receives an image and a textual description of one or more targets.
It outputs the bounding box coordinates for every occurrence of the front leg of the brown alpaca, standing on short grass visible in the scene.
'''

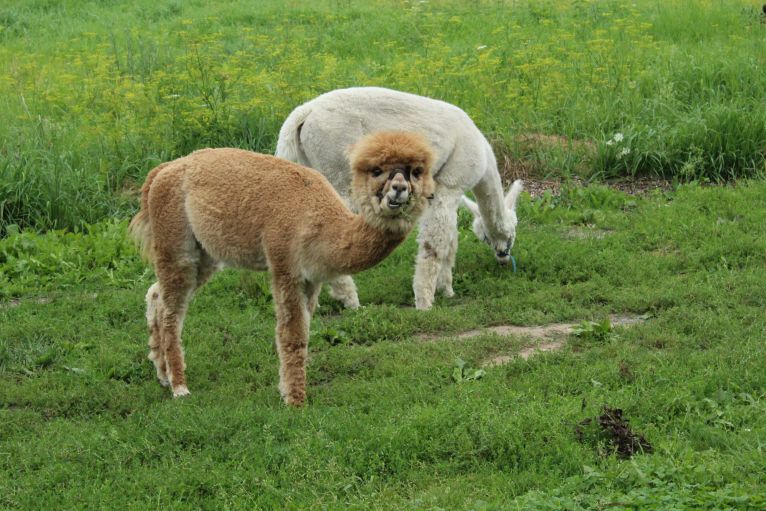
[273,277,309,406]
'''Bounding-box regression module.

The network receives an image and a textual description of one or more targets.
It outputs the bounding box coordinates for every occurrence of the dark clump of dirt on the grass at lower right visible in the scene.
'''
[575,405,654,459]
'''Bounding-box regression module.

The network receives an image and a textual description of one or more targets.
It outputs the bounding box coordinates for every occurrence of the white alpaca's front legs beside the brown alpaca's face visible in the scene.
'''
[412,188,462,309]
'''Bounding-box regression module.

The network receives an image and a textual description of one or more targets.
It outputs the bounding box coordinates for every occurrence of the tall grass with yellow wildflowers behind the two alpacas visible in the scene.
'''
[0,0,766,234]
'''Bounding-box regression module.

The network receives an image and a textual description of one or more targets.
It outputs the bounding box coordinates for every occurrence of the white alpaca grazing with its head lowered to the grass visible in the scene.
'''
[276,87,522,309]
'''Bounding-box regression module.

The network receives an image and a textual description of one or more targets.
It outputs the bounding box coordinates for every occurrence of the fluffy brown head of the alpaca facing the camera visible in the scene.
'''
[348,132,434,235]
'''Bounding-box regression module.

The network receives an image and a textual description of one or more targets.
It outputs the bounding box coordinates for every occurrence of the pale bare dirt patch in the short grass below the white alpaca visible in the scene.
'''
[418,314,645,367]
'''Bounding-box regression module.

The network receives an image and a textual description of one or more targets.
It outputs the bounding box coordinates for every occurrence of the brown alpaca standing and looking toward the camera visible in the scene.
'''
[130,132,434,405]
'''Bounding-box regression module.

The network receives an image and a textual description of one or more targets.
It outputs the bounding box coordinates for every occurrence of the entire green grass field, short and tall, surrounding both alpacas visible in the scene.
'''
[0,0,766,511]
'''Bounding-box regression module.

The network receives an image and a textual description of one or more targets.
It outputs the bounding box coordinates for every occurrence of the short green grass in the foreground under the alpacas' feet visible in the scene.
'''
[0,181,766,511]
